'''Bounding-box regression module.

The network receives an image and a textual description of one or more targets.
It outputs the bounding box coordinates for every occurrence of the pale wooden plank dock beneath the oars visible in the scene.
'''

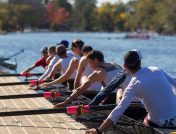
[0,77,87,134]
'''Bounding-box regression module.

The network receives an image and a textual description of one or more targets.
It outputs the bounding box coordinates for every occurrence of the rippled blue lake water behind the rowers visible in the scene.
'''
[0,32,176,77]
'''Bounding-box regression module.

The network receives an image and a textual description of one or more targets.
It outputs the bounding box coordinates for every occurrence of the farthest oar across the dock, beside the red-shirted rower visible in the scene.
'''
[0,73,43,77]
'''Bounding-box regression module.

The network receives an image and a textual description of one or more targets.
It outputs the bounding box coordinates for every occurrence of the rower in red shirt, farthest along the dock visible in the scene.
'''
[23,47,48,73]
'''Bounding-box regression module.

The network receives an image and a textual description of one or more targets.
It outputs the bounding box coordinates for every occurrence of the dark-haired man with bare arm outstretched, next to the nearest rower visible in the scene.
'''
[50,50,122,108]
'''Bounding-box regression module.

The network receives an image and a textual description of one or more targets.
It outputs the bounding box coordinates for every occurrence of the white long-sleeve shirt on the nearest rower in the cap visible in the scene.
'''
[108,66,176,122]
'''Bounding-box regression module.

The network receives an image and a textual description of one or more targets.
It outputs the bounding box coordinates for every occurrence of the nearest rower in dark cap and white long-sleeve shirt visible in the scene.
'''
[86,51,176,134]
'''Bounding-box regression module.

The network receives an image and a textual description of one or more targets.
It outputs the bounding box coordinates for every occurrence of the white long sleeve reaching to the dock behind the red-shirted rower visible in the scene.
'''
[39,54,60,80]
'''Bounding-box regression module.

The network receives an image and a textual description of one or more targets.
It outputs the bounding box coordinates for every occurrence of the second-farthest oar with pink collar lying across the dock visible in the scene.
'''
[0,80,51,86]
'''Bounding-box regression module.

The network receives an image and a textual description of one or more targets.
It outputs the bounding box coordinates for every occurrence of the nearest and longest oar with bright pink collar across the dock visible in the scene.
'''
[0,104,116,117]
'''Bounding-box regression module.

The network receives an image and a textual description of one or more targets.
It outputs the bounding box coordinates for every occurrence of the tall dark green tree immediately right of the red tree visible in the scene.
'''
[70,0,96,31]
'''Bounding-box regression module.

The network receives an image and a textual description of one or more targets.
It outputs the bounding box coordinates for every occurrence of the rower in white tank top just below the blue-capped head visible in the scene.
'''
[44,45,76,80]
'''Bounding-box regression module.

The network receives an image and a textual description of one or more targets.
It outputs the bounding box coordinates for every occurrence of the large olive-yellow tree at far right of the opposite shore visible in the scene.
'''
[126,0,176,34]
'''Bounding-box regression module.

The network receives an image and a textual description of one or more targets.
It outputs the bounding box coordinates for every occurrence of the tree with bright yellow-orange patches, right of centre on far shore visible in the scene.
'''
[96,2,127,31]
